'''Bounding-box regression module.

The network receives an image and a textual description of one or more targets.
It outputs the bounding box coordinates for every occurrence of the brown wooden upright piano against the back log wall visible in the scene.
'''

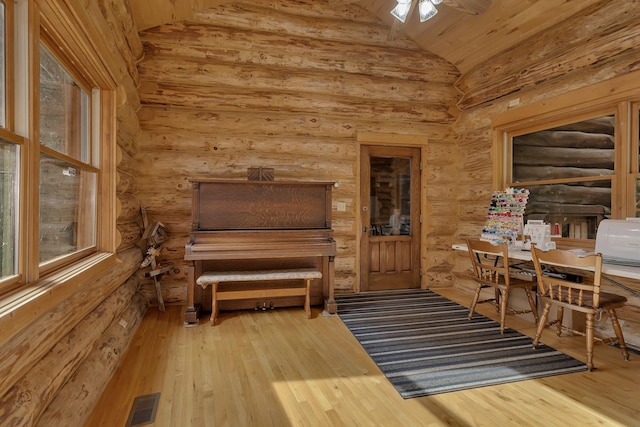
[185,179,337,325]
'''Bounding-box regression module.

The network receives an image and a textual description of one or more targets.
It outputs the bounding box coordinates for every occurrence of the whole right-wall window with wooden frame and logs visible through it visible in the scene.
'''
[493,82,640,240]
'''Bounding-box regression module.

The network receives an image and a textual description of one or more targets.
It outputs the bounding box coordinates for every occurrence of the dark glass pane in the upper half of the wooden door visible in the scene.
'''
[370,156,411,236]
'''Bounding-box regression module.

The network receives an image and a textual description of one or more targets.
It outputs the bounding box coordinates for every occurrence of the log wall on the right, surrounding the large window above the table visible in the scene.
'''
[450,1,640,347]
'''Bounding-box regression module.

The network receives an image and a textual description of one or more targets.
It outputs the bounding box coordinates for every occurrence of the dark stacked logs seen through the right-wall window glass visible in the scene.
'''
[512,115,615,239]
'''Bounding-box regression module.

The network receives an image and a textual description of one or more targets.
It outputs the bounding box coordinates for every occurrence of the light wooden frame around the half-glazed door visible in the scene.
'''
[355,132,428,293]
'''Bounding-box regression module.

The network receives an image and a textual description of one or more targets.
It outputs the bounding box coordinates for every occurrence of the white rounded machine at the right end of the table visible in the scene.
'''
[595,218,640,267]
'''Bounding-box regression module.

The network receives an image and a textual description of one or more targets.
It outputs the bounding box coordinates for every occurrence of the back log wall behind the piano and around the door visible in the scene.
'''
[136,0,459,304]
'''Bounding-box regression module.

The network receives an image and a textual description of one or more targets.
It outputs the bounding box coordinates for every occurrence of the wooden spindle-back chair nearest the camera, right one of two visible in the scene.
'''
[532,247,629,371]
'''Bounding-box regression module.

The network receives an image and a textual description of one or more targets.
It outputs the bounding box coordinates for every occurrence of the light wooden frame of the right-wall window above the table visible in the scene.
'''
[492,72,640,245]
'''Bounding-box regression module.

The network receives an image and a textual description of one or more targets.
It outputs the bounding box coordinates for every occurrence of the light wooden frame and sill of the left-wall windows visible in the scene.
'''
[0,0,119,308]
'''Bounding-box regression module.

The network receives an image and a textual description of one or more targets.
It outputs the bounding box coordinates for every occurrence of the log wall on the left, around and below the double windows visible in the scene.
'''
[0,0,149,426]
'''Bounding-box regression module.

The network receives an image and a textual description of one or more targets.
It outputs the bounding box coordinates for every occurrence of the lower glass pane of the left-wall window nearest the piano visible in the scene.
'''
[40,154,96,263]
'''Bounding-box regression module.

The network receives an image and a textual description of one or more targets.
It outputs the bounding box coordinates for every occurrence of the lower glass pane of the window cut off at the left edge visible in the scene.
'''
[0,140,18,279]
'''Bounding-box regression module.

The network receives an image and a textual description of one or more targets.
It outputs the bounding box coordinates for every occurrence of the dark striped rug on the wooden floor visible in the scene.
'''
[336,290,587,399]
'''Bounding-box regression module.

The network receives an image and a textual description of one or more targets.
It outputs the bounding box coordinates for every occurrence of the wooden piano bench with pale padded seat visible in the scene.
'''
[196,268,322,326]
